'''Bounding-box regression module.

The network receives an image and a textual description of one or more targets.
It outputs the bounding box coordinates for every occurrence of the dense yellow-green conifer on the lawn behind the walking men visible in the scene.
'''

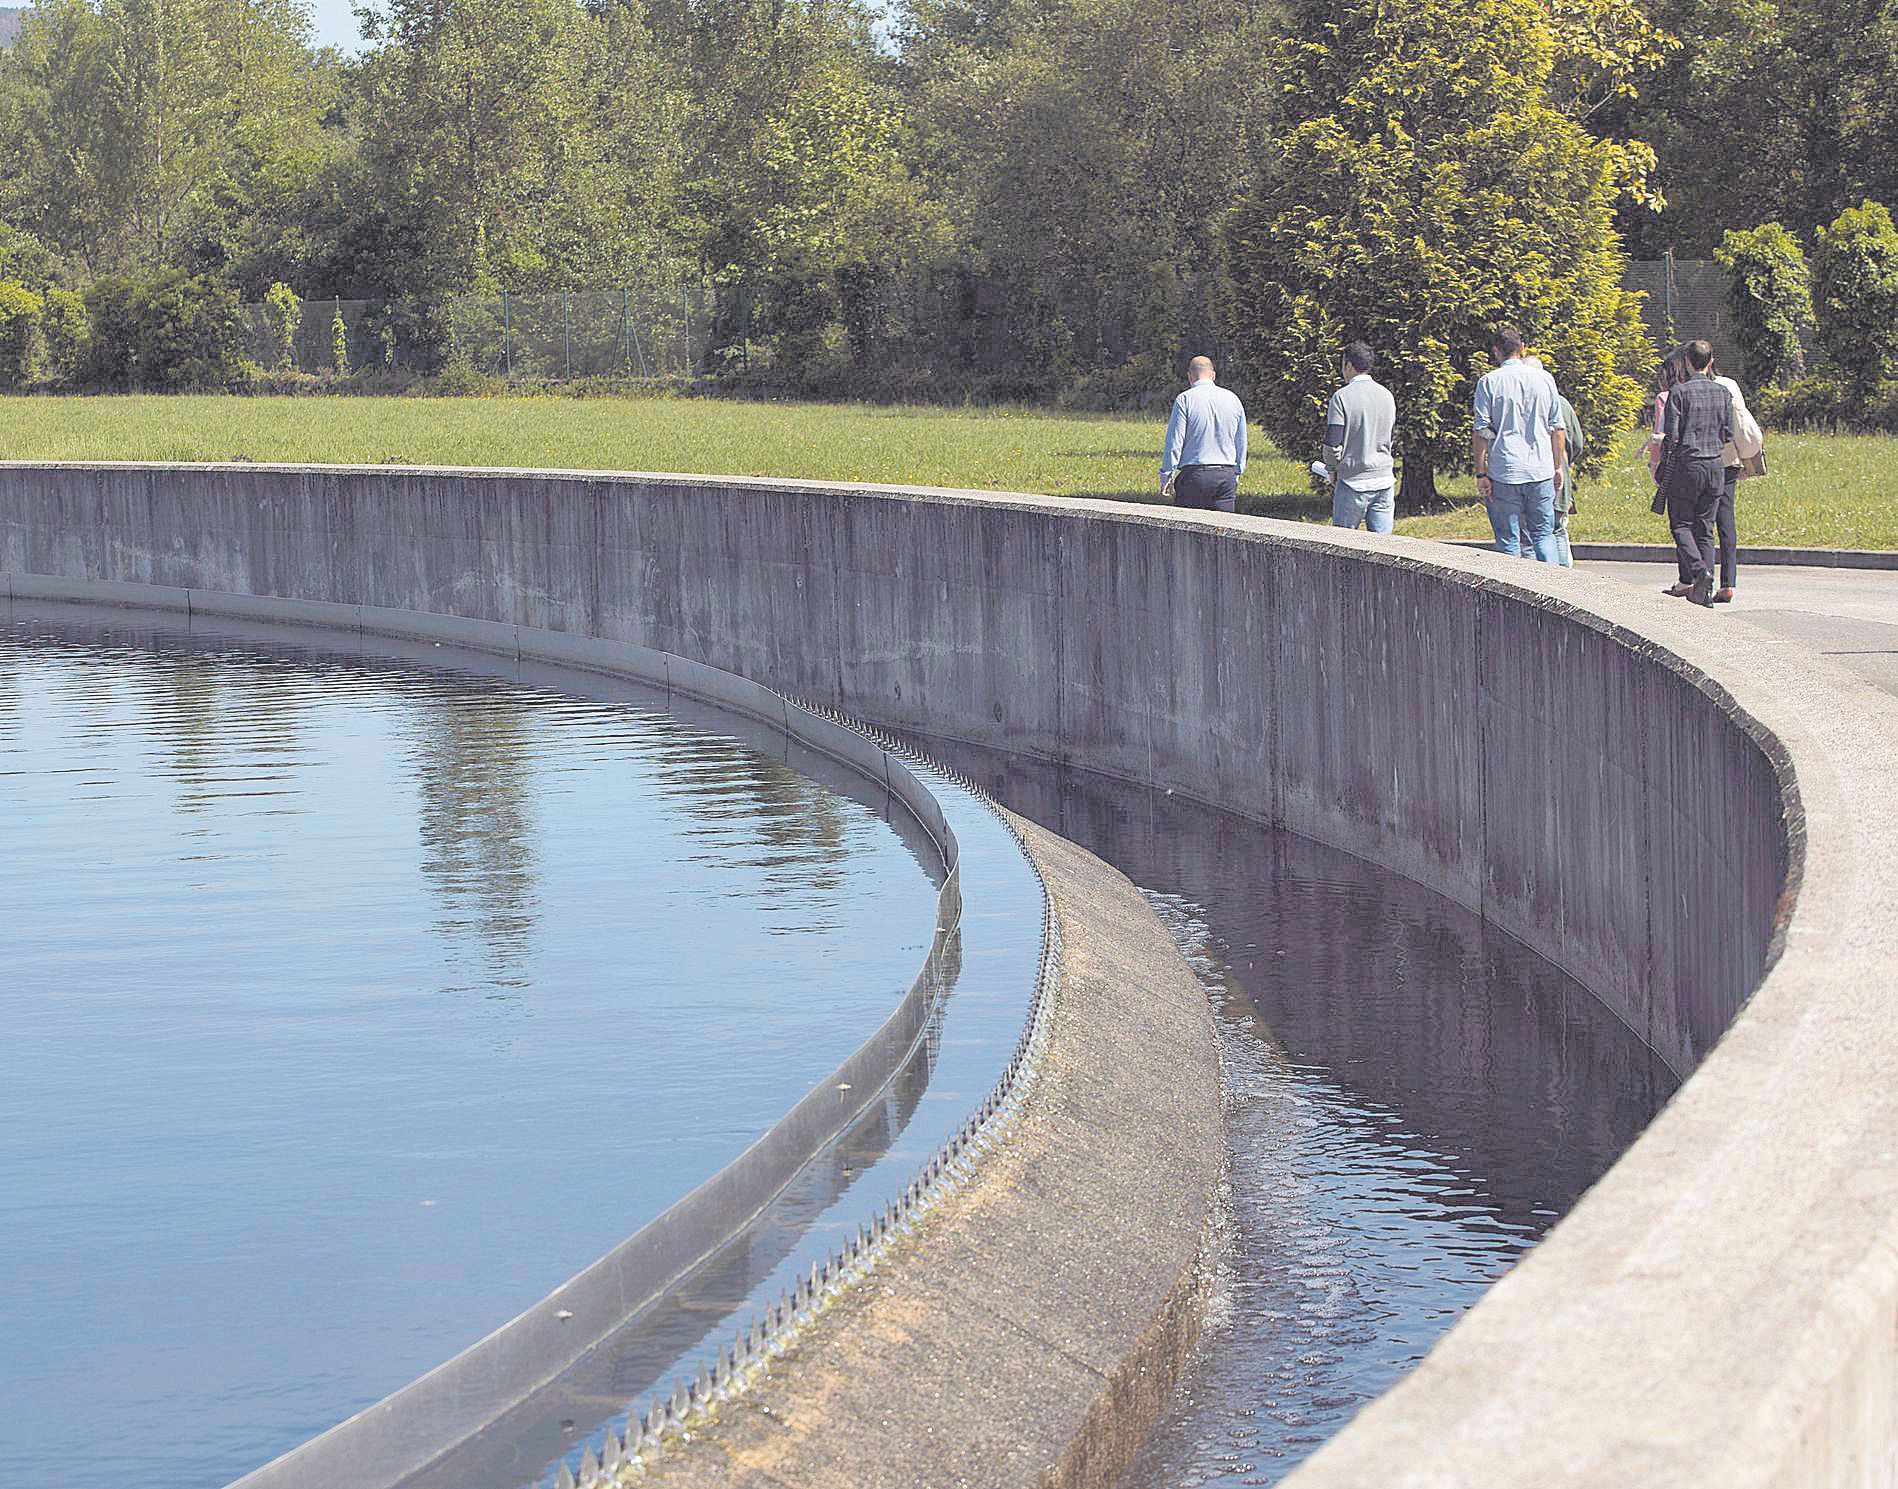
[1224,0,1653,510]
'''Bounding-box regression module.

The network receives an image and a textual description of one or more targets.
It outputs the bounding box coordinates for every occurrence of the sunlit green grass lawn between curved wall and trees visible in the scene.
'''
[0,396,1898,548]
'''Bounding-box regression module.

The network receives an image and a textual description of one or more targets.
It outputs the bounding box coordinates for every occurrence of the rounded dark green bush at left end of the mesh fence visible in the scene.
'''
[80,269,245,393]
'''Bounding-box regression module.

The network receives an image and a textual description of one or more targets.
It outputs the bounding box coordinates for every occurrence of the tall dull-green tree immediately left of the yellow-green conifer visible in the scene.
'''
[902,0,1274,398]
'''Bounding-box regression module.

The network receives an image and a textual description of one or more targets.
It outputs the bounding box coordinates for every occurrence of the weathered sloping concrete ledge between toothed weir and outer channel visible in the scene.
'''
[642,819,1220,1489]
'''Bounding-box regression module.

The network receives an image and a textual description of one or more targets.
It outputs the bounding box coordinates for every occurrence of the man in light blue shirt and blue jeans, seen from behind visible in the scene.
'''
[1469,326,1568,563]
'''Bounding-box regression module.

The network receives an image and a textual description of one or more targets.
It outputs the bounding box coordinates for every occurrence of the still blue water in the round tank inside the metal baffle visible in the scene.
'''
[0,605,940,1489]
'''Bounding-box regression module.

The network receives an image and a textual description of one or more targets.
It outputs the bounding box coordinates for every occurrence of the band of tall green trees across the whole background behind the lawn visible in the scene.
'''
[0,0,1898,485]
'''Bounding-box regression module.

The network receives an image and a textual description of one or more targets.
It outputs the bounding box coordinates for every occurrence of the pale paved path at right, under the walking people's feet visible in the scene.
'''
[1575,560,1898,696]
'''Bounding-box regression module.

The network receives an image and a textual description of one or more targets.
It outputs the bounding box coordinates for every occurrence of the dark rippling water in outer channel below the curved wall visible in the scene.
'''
[892,742,1674,1489]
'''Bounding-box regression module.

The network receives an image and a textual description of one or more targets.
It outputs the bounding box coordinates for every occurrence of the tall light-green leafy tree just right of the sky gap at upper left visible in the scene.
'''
[340,0,678,294]
